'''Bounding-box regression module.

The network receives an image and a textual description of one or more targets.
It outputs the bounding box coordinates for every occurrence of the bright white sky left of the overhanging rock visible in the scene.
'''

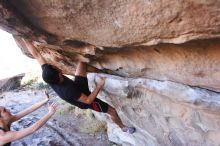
[0,29,40,79]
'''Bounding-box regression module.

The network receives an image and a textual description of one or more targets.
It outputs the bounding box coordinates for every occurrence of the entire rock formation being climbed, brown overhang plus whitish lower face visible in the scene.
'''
[0,0,220,146]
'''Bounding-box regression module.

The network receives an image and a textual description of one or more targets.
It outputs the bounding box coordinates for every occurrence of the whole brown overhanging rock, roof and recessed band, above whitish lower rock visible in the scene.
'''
[0,0,220,91]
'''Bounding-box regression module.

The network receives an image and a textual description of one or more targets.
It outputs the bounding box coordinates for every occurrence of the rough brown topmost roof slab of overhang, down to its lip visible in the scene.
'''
[3,0,220,47]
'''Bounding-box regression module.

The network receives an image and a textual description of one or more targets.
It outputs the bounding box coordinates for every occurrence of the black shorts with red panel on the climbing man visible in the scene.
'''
[75,76,109,113]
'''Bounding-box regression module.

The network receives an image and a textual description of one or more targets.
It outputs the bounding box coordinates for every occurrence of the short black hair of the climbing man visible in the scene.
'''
[41,64,60,84]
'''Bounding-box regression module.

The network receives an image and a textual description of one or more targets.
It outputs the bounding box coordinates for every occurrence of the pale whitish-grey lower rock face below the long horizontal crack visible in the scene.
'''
[89,74,220,146]
